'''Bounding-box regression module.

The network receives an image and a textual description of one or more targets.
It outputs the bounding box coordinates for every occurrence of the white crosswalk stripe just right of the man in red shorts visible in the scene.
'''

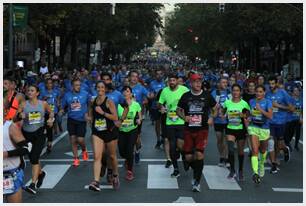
[203,165,241,190]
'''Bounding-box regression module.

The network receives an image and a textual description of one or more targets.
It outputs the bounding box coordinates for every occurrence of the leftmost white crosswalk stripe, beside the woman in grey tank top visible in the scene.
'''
[27,164,71,189]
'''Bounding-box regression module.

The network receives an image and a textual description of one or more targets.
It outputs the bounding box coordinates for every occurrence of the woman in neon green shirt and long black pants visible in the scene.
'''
[118,86,142,181]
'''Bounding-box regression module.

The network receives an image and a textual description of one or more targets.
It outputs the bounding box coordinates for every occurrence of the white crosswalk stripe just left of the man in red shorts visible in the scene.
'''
[147,165,178,189]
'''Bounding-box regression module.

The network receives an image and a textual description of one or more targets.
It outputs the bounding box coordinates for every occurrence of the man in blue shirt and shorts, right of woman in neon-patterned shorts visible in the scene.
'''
[266,76,293,174]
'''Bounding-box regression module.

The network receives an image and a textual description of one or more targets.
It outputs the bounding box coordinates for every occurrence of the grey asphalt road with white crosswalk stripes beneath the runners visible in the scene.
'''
[23,116,303,203]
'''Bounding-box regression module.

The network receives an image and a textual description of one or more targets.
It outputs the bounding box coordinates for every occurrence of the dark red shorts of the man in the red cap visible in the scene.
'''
[184,129,208,154]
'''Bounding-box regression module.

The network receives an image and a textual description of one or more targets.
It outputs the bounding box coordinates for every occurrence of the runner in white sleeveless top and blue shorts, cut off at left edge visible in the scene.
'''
[3,92,29,203]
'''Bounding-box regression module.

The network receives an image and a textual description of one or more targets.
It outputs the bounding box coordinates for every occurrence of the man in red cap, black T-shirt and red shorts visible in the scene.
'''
[176,74,216,192]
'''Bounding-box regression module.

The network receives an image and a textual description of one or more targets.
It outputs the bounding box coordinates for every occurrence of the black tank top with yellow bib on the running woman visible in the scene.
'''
[92,97,115,132]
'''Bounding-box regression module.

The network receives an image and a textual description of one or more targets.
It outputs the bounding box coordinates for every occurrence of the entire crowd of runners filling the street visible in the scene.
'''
[3,60,303,202]
